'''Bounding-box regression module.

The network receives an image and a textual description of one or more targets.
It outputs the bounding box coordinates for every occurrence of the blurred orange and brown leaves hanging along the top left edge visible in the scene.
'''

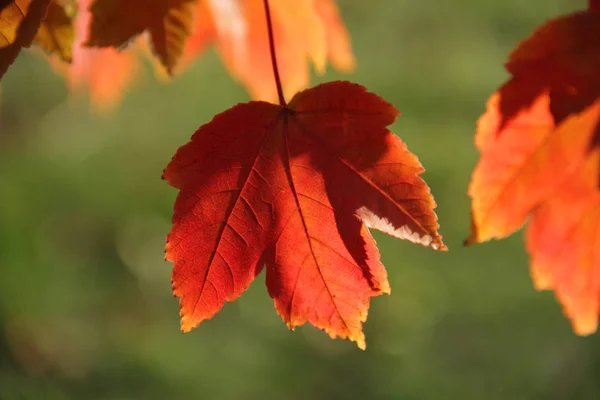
[0,0,355,111]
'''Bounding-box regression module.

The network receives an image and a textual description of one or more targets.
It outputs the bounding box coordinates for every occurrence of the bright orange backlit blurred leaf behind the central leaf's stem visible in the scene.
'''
[159,0,355,101]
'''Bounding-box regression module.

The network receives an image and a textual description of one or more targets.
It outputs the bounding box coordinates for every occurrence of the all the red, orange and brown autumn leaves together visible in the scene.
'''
[0,0,600,349]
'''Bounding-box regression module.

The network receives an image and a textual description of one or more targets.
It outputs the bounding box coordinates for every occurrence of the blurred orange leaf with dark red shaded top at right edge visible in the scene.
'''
[466,3,600,334]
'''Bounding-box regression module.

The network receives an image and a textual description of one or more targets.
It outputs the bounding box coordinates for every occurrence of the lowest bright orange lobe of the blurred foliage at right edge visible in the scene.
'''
[527,145,600,335]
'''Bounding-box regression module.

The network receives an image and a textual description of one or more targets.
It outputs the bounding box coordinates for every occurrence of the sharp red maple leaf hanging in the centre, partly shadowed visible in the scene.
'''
[163,81,446,349]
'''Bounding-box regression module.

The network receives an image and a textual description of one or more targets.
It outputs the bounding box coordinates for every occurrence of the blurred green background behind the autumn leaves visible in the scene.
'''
[0,0,600,400]
